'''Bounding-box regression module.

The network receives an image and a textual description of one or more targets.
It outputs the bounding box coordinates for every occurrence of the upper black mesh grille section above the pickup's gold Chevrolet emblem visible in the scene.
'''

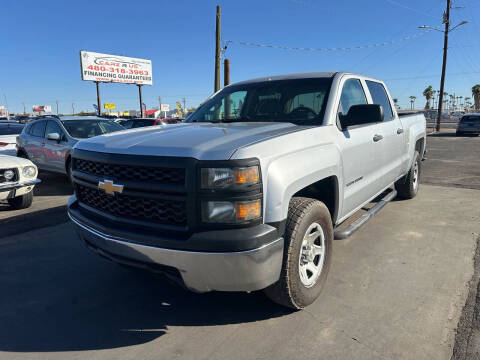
[73,159,185,185]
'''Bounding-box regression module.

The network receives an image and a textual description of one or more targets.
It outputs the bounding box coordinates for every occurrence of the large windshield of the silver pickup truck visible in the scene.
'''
[185,78,332,125]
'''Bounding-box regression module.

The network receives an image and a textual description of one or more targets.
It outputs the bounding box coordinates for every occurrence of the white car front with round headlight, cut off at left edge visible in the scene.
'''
[0,155,40,210]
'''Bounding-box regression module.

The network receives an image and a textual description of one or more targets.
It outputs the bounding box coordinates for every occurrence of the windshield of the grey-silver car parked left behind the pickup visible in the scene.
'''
[62,119,125,139]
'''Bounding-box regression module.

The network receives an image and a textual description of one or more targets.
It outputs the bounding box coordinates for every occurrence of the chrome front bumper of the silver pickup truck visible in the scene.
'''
[68,213,283,292]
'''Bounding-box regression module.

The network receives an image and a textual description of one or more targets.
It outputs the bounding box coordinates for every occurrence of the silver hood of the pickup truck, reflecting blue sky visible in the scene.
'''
[75,122,305,160]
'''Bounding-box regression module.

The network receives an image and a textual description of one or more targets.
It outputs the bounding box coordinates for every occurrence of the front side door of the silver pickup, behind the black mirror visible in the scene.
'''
[338,78,379,216]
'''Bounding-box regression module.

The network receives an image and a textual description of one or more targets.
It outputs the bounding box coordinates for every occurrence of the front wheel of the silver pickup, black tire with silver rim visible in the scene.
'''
[264,197,333,310]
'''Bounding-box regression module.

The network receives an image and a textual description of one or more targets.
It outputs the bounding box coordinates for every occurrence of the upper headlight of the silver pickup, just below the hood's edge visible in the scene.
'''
[201,166,260,189]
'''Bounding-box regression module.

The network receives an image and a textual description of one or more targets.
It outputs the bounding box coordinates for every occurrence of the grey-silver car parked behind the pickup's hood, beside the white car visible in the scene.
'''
[17,116,125,176]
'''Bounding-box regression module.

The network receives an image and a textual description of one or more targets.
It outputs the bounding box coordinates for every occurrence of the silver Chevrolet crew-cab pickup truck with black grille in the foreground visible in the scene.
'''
[68,72,426,309]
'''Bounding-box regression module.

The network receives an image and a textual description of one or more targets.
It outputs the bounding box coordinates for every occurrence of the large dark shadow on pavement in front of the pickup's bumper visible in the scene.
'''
[0,227,290,352]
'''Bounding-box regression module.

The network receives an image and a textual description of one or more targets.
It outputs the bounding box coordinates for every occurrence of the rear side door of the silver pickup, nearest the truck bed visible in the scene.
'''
[365,80,407,187]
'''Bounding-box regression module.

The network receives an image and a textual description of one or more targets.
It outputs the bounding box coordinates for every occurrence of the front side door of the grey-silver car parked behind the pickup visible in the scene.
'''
[44,120,69,173]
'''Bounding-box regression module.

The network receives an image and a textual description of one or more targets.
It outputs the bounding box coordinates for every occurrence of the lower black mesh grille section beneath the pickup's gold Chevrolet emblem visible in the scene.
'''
[76,184,187,226]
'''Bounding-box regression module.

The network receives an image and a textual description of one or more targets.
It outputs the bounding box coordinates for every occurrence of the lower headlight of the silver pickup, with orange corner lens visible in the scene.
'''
[202,200,262,224]
